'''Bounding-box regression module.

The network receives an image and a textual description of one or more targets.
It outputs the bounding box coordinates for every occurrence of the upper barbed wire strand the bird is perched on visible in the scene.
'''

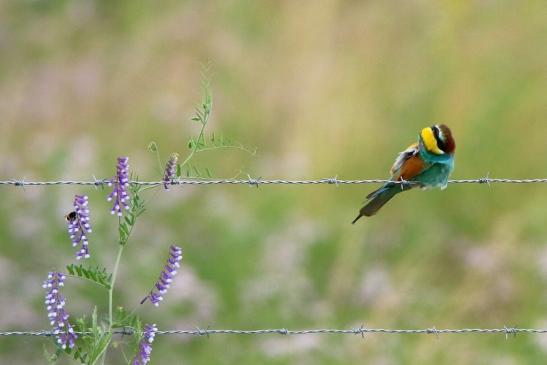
[0,176,547,187]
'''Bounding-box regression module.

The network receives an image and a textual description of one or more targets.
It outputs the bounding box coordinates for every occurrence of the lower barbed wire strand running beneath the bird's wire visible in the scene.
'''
[0,326,547,339]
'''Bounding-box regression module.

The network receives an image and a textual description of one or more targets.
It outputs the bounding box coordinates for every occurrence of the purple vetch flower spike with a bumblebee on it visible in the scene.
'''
[66,195,91,260]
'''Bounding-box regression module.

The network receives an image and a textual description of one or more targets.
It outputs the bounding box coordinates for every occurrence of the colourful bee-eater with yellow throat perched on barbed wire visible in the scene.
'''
[352,124,456,223]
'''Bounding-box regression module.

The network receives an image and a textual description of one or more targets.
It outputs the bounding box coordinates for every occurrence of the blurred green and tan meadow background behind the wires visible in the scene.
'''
[0,0,547,365]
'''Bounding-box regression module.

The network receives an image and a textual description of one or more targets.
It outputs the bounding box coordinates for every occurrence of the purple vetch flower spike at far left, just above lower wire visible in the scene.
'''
[42,272,78,349]
